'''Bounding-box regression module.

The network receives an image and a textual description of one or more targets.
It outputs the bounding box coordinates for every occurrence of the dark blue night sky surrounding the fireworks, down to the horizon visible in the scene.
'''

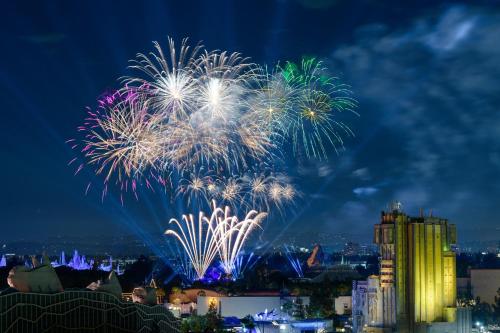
[0,0,500,242]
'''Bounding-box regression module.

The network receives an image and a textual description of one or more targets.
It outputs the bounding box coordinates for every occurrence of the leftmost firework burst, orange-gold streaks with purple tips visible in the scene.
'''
[70,91,163,198]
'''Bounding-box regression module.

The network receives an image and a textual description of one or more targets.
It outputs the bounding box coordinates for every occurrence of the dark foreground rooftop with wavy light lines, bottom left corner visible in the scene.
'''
[0,291,180,333]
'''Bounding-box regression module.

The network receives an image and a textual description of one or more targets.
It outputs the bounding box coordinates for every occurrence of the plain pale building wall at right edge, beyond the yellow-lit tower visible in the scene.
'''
[470,269,500,304]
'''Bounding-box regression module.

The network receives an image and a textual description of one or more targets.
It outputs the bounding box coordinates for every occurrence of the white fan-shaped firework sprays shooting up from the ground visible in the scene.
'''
[165,202,267,279]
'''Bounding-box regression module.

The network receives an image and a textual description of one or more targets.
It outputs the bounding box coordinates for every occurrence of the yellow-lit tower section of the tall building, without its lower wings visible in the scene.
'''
[374,207,457,333]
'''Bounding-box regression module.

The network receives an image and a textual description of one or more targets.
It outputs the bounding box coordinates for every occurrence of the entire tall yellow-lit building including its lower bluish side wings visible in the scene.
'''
[353,205,470,333]
